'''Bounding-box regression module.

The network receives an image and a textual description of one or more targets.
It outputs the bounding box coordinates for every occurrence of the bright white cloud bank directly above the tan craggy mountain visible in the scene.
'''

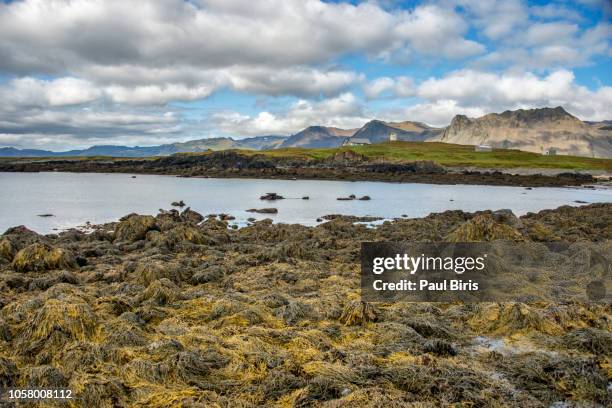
[381,70,612,126]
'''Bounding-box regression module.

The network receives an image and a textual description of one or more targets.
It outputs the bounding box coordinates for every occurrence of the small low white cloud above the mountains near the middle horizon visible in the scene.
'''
[211,93,369,136]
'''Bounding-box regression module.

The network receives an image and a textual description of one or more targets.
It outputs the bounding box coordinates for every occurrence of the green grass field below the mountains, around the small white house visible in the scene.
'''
[255,142,612,171]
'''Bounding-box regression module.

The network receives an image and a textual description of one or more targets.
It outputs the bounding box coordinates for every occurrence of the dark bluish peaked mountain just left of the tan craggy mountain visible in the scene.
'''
[352,120,442,143]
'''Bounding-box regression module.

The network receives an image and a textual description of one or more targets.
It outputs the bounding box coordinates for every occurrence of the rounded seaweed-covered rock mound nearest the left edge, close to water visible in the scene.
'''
[13,243,77,272]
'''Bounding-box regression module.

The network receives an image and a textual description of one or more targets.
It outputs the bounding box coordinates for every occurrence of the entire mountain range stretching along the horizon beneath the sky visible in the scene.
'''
[0,106,612,158]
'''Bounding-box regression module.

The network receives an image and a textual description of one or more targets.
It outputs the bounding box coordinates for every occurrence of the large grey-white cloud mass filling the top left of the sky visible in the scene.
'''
[0,0,482,79]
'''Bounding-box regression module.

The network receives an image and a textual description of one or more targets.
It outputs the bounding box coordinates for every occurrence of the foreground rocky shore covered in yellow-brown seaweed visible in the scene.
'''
[0,204,612,407]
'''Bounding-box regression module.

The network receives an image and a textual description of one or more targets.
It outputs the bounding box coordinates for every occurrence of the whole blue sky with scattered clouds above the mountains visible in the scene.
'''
[0,0,612,150]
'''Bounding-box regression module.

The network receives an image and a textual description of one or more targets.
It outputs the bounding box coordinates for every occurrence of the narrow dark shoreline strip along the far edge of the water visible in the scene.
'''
[0,159,610,187]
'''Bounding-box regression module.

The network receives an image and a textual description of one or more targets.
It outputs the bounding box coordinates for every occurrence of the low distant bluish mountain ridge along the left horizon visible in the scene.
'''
[0,135,286,157]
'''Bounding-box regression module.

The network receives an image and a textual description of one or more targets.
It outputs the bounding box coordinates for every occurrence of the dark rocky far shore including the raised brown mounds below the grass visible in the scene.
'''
[0,151,602,187]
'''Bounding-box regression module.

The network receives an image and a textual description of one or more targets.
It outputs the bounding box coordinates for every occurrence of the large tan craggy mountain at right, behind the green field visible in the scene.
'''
[440,106,612,157]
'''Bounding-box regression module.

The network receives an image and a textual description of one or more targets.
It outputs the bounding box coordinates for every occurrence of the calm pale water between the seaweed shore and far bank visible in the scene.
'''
[0,173,612,233]
